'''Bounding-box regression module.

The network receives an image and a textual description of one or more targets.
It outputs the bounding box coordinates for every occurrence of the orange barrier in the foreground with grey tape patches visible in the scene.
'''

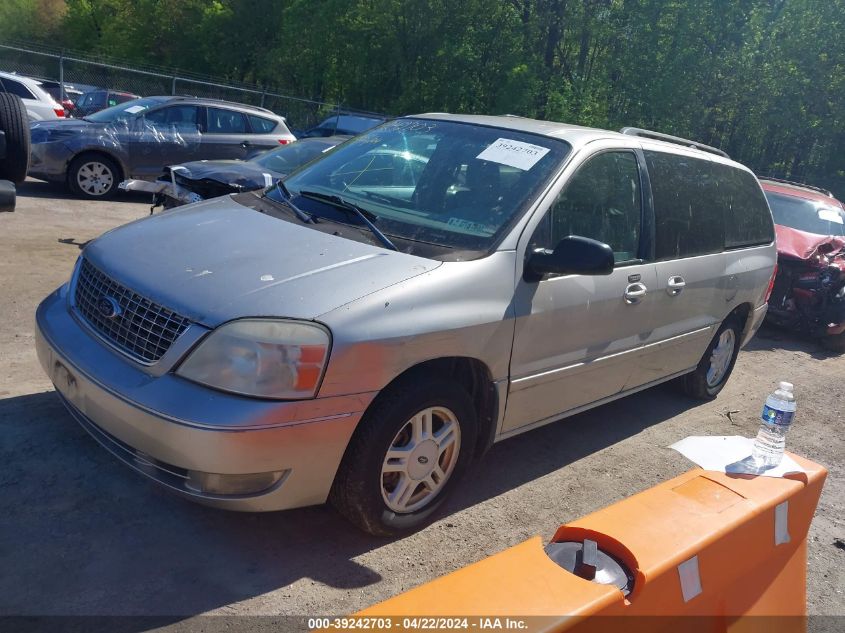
[342,456,827,633]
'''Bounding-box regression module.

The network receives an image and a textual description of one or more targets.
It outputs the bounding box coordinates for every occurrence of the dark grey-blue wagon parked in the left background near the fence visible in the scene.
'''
[30,96,296,198]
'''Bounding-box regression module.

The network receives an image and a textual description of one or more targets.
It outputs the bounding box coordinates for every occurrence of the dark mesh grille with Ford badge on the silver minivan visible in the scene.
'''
[74,259,191,364]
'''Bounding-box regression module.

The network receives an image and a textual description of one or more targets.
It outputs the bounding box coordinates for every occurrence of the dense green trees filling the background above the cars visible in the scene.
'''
[0,0,845,195]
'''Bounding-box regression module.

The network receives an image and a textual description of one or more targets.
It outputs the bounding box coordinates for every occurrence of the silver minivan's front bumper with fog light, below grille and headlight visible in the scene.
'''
[35,285,375,511]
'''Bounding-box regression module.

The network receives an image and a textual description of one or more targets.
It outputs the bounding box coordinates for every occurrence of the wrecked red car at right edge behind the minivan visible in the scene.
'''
[760,178,845,352]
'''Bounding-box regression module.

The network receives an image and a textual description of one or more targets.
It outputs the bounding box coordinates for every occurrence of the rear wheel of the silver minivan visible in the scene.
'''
[680,316,742,400]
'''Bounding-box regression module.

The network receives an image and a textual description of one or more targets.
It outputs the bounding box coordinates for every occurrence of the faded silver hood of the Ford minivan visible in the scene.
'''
[83,196,440,327]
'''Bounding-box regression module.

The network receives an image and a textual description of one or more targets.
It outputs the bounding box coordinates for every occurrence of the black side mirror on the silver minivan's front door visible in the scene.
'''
[525,235,615,281]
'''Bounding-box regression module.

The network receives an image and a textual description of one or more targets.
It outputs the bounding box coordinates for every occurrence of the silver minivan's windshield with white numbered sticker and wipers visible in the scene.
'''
[267,118,571,252]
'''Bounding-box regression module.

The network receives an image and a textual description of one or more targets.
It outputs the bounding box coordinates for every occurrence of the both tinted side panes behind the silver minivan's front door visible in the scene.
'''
[645,151,774,259]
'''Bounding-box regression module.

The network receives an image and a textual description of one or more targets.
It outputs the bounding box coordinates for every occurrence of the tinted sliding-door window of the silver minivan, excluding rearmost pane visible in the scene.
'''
[645,151,725,259]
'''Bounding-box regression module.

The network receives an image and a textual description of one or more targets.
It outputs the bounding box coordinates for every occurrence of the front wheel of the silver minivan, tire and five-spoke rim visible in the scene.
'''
[329,376,477,536]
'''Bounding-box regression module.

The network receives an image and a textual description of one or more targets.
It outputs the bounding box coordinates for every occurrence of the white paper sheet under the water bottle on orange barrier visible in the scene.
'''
[669,435,806,477]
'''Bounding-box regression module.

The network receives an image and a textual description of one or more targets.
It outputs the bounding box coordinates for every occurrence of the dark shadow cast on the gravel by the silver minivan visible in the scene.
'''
[0,376,694,631]
